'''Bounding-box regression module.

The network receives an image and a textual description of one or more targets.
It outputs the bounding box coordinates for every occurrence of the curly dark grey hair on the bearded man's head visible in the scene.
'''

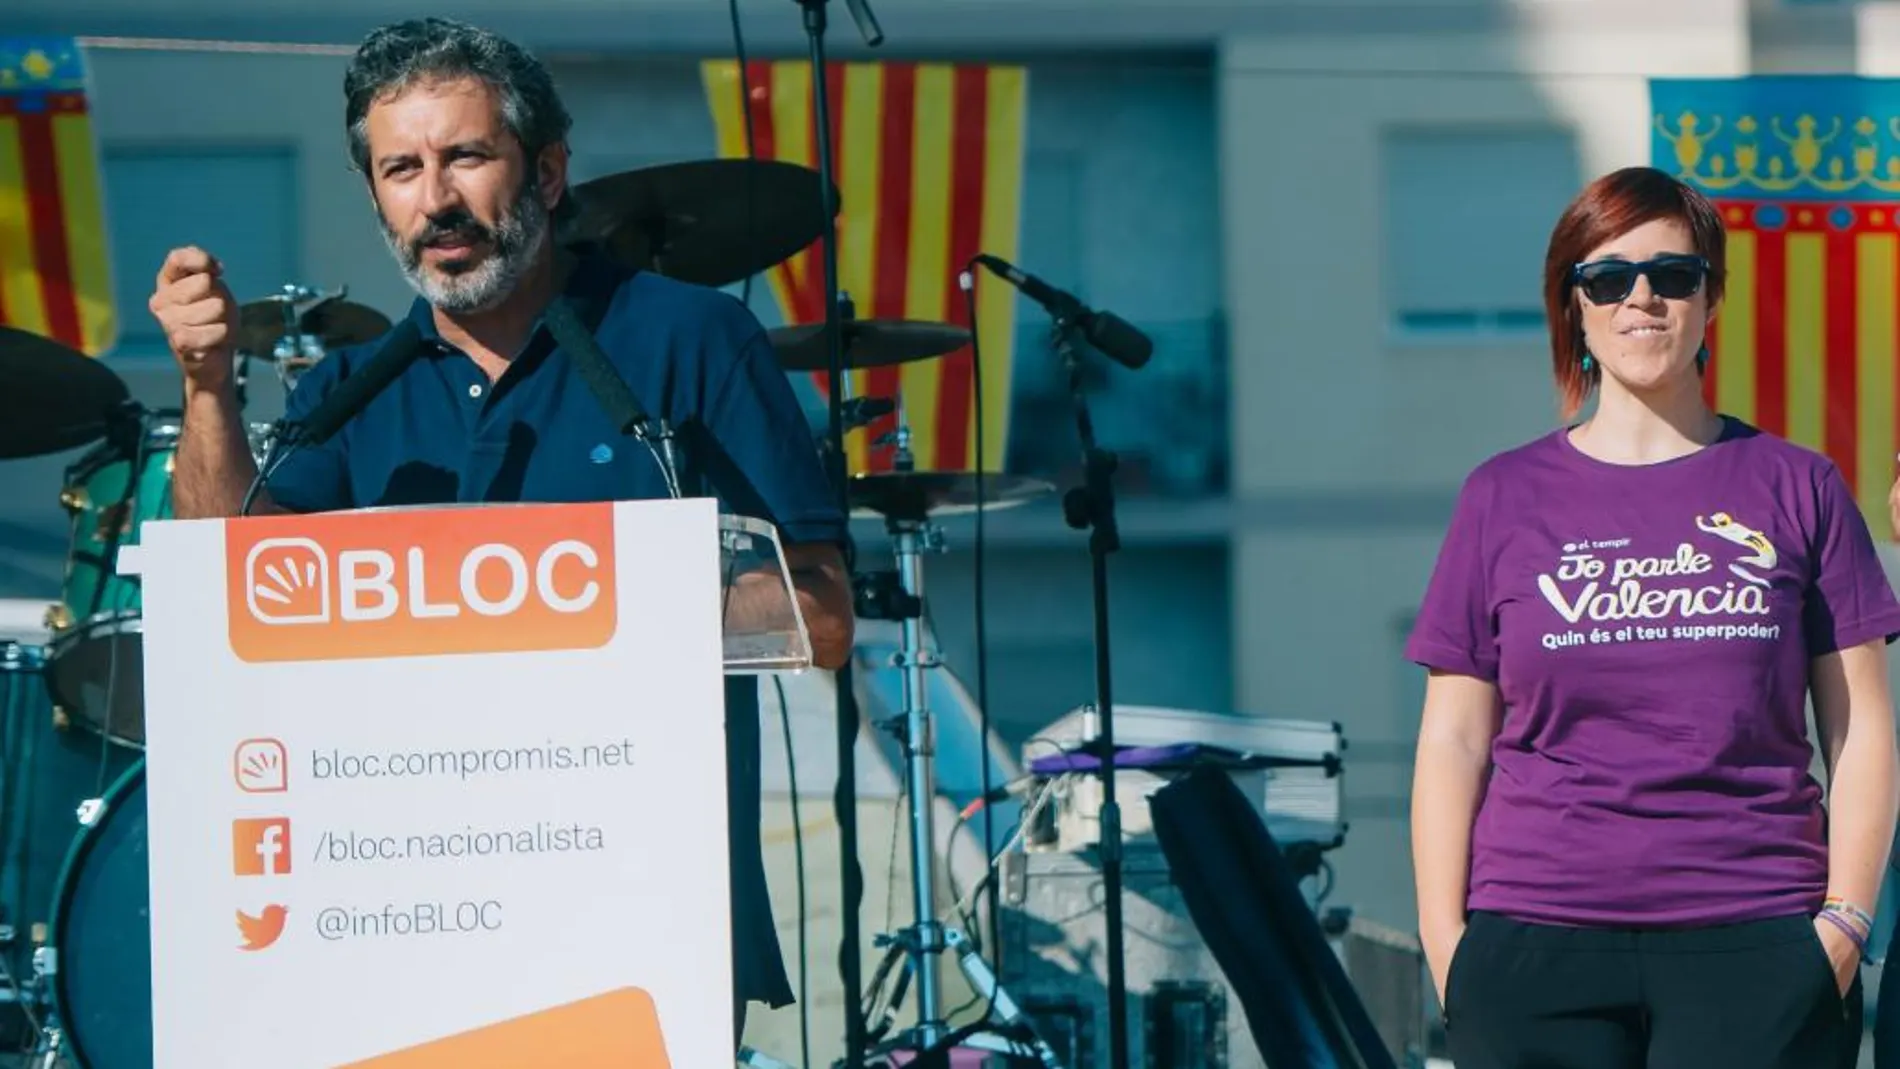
[344,17,574,211]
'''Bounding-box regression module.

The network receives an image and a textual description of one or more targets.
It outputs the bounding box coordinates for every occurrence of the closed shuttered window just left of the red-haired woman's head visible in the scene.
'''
[1383,129,1581,338]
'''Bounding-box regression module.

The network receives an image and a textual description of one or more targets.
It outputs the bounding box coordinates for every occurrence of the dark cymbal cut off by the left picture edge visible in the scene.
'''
[0,327,131,459]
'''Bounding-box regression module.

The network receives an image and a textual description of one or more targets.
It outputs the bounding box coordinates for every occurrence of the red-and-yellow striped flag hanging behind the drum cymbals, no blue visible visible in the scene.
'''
[701,61,1028,473]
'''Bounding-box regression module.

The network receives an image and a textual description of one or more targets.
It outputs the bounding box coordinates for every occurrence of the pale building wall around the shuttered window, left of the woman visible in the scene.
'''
[1220,2,1750,928]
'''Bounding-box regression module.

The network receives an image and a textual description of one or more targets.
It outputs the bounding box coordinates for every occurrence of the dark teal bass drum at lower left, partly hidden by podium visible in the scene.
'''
[51,760,152,1069]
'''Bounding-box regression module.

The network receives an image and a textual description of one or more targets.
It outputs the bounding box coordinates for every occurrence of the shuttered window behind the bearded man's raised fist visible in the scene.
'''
[101,144,296,359]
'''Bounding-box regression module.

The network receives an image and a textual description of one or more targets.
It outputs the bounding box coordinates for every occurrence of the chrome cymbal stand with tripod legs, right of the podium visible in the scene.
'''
[855,425,1062,1069]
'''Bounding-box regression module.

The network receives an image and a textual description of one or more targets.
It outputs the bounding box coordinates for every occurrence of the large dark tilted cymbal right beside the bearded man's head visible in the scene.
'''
[562,159,838,287]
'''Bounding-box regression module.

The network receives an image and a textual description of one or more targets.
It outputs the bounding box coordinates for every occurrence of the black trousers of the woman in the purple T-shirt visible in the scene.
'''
[1444,913,1862,1069]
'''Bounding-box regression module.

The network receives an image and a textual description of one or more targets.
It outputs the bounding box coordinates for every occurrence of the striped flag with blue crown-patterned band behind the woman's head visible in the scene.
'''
[1649,76,1900,539]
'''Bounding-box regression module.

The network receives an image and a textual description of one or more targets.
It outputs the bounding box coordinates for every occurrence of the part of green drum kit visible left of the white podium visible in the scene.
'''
[0,287,390,1069]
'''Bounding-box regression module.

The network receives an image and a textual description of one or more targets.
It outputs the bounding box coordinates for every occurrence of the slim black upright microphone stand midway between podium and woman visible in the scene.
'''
[1051,306,1129,1069]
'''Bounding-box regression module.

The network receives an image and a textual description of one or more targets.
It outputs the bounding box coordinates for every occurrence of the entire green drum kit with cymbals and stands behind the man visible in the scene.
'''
[0,159,1055,1069]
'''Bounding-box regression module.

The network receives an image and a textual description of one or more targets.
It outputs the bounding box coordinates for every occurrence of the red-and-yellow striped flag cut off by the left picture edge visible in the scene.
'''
[0,38,118,355]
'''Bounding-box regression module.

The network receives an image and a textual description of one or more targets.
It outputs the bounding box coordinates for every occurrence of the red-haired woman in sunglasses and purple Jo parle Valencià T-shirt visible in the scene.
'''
[1406,167,1900,1069]
